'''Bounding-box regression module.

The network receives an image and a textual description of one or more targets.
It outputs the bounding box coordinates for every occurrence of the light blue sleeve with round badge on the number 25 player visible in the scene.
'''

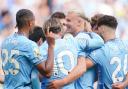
[24,42,43,65]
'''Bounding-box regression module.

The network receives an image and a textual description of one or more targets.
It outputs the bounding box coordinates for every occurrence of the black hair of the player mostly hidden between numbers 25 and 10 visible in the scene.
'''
[29,26,46,42]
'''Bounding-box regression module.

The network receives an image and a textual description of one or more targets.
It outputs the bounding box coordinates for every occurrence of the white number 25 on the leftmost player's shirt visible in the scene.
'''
[2,49,19,75]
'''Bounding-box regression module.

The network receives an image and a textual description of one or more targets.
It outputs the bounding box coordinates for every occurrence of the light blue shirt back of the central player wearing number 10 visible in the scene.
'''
[40,38,77,89]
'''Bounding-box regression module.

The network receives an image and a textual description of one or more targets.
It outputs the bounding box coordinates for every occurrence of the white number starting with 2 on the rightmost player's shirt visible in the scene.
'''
[110,55,128,83]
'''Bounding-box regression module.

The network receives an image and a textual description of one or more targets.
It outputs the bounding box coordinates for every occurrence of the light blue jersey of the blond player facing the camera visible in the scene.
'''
[75,32,103,89]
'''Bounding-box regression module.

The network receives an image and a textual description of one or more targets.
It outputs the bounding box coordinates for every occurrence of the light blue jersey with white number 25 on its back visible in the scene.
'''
[1,33,43,89]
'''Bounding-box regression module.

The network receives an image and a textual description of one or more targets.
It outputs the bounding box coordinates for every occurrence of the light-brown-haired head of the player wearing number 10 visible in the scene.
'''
[43,18,63,36]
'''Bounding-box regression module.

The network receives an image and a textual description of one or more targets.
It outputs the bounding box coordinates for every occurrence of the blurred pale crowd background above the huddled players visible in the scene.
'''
[0,0,128,45]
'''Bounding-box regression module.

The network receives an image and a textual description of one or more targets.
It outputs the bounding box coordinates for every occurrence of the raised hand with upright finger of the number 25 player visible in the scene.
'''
[46,27,55,47]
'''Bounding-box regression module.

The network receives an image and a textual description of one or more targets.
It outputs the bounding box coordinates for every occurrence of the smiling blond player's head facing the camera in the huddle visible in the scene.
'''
[66,10,88,35]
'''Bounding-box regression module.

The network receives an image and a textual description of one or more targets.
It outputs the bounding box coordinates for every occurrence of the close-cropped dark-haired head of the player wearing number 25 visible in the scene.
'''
[16,9,35,28]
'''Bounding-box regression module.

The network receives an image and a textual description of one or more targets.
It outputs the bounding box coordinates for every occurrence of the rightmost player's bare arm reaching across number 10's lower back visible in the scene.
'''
[48,57,94,89]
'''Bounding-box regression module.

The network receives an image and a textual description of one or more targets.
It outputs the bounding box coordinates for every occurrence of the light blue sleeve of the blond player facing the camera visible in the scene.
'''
[76,32,104,57]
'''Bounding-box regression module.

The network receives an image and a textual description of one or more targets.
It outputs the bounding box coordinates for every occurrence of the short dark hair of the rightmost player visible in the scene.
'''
[97,15,118,29]
